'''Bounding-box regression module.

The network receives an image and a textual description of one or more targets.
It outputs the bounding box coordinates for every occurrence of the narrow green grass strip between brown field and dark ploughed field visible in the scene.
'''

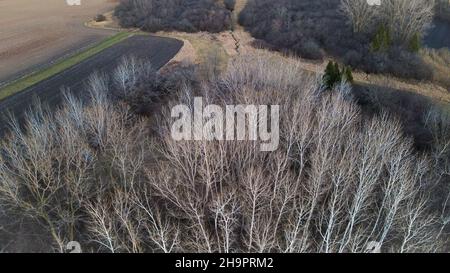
[0,32,130,100]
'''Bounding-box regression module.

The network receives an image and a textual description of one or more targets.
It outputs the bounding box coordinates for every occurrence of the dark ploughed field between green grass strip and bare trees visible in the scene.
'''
[0,35,183,135]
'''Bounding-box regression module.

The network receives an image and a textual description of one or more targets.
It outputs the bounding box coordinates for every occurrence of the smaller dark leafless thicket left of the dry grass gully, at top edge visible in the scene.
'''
[114,0,234,32]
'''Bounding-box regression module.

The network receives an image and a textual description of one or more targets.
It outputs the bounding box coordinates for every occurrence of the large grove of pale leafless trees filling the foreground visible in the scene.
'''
[0,54,450,252]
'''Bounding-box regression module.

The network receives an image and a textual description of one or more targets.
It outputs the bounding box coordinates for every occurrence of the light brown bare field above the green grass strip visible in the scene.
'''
[0,0,117,86]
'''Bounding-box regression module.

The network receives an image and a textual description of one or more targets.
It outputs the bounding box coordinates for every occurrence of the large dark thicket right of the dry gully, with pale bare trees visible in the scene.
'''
[240,0,433,80]
